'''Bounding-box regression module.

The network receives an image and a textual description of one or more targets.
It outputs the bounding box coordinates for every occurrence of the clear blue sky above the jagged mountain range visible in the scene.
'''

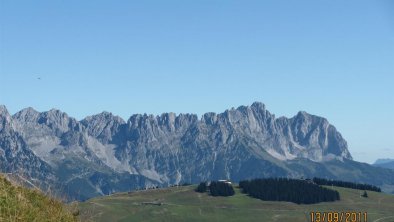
[0,0,394,162]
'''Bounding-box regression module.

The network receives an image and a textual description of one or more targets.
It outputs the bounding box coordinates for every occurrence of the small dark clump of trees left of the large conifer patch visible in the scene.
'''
[196,181,235,196]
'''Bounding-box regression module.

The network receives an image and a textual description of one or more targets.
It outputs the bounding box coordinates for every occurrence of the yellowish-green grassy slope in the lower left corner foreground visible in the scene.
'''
[0,175,77,222]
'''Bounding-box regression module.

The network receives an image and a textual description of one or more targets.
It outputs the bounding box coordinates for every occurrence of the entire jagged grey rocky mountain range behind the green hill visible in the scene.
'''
[0,103,394,199]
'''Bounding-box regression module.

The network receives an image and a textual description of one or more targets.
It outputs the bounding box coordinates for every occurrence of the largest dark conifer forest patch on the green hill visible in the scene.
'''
[239,178,340,204]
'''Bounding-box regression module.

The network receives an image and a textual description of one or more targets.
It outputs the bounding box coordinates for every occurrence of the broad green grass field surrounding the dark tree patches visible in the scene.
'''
[79,186,394,222]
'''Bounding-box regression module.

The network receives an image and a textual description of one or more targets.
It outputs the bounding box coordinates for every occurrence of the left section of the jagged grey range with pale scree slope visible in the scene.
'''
[0,107,156,200]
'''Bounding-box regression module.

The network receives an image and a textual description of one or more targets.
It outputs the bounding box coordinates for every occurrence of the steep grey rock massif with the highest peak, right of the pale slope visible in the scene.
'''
[106,103,351,183]
